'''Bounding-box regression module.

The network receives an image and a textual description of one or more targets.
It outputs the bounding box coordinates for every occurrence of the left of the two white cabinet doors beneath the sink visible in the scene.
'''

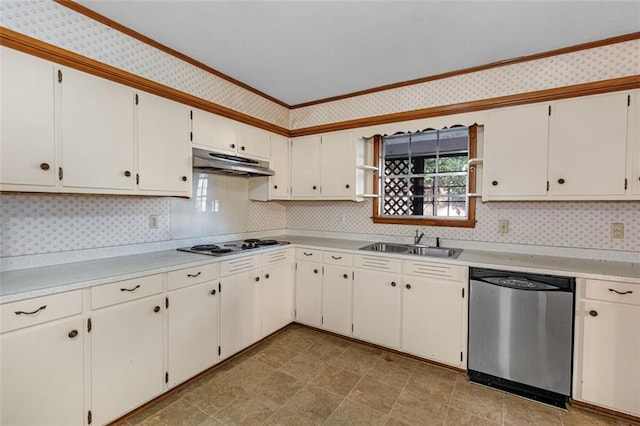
[353,270,402,349]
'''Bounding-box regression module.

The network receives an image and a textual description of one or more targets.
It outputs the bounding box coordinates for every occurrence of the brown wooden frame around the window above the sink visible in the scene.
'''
[371,124,478,228]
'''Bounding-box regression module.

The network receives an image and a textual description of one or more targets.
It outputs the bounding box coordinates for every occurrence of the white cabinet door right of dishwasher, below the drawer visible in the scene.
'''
[582,301,640,416]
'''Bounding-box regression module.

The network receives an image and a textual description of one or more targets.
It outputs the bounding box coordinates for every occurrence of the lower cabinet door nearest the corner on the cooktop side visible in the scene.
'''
[261,262,293,336]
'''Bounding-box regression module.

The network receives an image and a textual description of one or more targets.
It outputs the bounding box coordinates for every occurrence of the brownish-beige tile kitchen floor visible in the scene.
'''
[117,324,631,426]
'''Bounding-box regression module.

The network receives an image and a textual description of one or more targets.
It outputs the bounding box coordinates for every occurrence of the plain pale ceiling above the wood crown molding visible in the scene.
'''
[78,0,640,105]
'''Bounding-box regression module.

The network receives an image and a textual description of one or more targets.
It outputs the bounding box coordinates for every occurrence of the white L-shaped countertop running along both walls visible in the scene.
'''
[0,235,640,303]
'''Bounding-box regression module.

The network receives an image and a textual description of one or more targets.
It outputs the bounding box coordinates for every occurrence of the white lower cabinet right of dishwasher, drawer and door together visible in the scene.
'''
[573,280,640,416]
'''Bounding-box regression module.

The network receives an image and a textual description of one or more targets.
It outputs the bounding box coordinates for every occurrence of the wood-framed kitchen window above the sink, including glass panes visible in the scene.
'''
[373,125,477,227]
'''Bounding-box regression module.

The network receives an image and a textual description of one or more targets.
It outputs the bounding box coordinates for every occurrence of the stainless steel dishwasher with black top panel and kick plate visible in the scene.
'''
[467,268,575,408]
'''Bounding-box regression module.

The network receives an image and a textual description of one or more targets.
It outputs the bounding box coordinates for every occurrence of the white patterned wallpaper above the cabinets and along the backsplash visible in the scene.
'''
[0,0,640,257]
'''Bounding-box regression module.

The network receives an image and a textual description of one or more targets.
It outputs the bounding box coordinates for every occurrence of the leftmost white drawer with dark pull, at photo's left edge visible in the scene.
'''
[0,290,82,333]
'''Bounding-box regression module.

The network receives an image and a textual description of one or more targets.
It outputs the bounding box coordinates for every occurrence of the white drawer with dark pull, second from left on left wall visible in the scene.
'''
[91,274,162,309]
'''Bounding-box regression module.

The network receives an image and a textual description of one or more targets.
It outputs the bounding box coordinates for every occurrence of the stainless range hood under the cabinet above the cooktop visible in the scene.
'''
[193,148,275,177]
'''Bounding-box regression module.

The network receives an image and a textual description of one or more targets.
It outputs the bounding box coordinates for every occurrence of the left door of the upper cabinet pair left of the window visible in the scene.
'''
[291,136,320,197]
